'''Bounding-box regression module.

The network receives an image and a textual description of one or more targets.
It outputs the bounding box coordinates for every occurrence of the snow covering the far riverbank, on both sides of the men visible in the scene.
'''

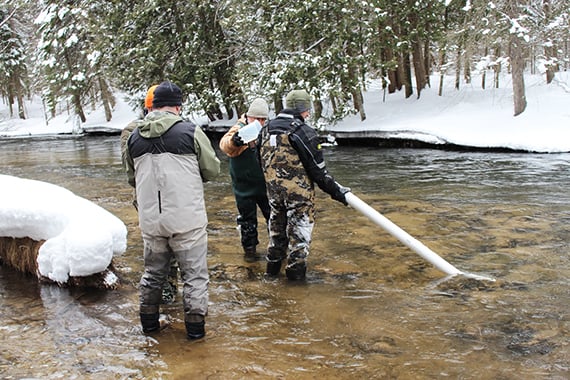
[0,72,570,153]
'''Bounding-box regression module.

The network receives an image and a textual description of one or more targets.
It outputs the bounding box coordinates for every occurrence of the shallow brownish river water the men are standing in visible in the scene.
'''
[0,136,570,379]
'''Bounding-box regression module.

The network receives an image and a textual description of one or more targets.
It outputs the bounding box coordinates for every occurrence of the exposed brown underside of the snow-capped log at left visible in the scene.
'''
[0,237,119,289]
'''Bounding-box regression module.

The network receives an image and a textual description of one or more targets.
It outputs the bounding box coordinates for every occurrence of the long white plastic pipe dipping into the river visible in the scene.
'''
[345,192,462,278]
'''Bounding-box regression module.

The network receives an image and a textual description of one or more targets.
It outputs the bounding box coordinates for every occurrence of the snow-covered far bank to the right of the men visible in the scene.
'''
[330,72,570,152]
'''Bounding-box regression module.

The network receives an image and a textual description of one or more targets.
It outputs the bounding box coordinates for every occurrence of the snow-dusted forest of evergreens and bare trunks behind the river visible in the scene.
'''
[0,0,570,129]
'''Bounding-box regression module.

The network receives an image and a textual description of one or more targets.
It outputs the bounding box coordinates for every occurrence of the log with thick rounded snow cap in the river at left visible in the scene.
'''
[0,175,127,289]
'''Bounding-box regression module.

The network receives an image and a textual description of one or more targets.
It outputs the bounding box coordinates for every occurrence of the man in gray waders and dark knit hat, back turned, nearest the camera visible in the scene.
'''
[127,82,220,339]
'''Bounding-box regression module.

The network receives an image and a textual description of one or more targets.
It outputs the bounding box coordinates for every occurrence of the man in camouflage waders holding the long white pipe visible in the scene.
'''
[260,90,350,280]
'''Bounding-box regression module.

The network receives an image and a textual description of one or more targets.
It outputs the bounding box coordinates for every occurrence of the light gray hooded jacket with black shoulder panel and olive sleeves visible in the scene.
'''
[126,111,220,236]
